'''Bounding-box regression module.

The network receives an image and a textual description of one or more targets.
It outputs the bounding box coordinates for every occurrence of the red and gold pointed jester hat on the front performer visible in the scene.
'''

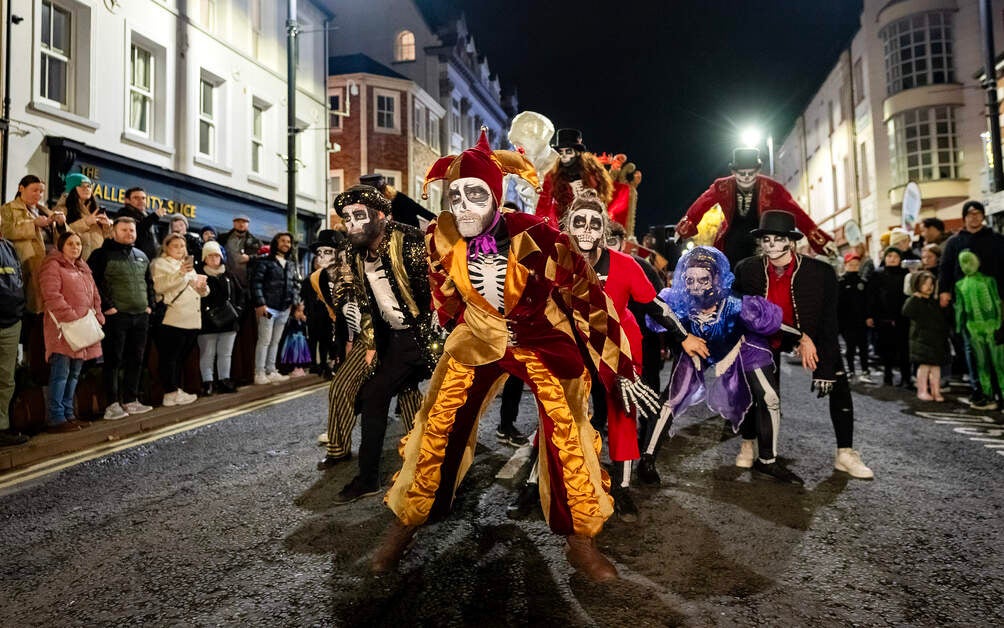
[422,127,540,205]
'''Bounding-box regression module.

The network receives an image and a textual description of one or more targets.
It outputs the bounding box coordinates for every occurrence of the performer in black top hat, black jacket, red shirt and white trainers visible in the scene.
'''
[735,210,874,483]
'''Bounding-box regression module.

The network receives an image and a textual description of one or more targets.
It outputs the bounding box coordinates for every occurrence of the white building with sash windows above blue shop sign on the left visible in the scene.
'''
[5,0,331,241]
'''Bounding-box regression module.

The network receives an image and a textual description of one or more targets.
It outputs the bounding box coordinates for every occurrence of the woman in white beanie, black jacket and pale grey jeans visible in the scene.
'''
[199,240,245,395]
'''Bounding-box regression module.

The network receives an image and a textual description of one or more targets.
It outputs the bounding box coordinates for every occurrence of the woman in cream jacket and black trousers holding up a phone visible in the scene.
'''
[151,233,209,406]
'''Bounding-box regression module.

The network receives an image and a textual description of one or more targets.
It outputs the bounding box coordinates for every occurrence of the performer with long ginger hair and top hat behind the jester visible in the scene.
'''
[535,129,613,225]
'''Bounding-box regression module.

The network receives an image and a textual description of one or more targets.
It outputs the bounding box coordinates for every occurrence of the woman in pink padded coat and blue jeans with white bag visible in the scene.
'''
[38,232,104,433]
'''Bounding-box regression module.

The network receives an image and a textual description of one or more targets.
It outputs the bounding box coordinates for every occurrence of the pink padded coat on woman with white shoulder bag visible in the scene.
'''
[38,251,104,361]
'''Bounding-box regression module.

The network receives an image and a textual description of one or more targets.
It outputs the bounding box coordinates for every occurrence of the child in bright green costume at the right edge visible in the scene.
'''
[955,249,1004,399]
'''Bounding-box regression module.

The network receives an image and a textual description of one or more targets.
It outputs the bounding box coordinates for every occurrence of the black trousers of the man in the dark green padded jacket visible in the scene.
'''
[101,311,150,405]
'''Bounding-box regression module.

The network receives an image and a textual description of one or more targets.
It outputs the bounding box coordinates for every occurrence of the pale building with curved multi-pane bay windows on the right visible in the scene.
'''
[776,0,1004,254]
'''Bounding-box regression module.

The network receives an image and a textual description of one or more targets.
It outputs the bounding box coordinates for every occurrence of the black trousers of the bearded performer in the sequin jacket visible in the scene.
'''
[357,330,426,486]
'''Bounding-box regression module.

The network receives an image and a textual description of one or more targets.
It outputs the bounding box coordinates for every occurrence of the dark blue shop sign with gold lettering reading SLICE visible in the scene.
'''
[70,158,321,240]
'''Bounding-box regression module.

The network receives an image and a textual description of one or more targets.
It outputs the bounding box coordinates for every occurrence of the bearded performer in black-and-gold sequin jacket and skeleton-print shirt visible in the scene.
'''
[319,185,437,503]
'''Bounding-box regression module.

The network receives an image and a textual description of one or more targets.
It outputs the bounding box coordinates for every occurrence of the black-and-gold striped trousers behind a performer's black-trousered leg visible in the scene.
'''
[327,344,422,457]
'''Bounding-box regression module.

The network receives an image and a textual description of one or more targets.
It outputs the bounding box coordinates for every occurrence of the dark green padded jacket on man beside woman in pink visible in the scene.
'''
[87,240,154,315]
